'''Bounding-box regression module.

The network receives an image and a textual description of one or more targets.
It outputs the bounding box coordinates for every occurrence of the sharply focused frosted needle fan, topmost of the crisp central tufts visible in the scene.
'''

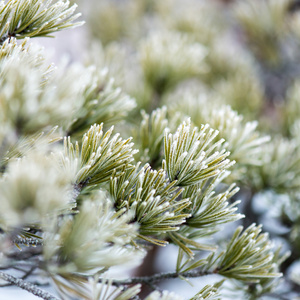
[163,119,234,186]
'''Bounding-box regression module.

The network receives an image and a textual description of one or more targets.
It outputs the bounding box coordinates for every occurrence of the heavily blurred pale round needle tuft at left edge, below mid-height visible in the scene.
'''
[0,151,74,229]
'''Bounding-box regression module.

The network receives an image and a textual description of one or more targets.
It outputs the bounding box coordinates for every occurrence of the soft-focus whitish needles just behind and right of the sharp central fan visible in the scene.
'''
[169,99,270,180]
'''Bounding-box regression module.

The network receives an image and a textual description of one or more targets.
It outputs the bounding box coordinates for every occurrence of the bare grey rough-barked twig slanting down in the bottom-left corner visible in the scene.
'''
[0,272,58,300]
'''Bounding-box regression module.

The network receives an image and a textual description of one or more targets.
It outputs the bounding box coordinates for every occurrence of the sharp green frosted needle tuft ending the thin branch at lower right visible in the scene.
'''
[176,224,289,286]
